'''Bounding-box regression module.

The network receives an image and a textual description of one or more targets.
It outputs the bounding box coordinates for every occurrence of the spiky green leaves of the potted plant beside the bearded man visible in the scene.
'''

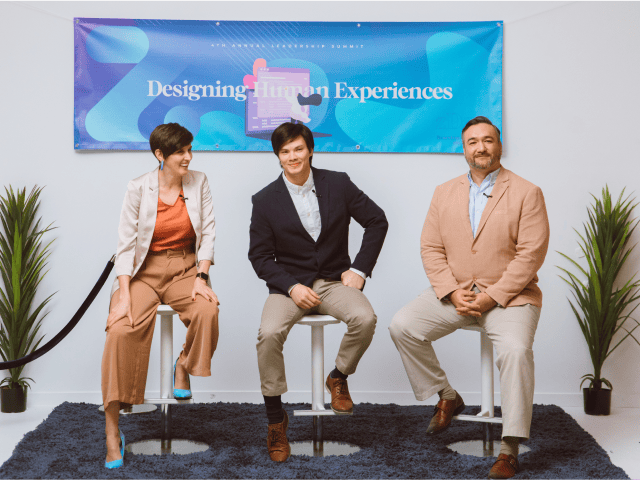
[558,186,640,389]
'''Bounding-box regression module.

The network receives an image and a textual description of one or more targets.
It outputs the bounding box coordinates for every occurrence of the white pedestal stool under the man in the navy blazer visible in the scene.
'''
[291,315,360,457]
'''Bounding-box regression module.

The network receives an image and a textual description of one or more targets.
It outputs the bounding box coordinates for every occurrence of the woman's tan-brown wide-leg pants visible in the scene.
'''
[102,250,218,408]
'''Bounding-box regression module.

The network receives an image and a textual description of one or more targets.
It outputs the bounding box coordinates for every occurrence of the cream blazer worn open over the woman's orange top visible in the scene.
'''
[111,168,216,295]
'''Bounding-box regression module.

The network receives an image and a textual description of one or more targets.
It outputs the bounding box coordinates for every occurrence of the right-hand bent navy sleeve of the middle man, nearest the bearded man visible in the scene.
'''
[344,173,389,277]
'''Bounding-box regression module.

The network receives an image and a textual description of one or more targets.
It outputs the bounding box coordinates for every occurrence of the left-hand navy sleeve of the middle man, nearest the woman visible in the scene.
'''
[249,198,298,293]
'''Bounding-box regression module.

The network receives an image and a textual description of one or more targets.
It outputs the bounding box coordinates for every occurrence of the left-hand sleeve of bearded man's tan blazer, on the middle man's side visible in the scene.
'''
[420,187,460,300]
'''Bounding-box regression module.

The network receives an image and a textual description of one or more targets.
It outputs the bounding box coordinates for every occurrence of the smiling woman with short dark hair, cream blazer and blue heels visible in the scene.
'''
[102,123,219,468]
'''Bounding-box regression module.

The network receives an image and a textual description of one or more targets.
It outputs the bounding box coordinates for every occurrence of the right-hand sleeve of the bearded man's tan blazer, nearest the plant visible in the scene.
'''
[486,187,549,306]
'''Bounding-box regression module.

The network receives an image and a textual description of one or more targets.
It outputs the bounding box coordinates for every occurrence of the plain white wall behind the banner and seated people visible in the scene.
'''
[0,0,640,406]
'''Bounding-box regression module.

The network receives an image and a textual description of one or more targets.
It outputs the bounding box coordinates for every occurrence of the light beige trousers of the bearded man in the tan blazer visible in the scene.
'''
[389,287,540,438]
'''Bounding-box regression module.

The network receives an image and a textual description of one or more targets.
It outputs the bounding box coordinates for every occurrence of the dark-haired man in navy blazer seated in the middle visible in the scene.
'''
[249,123,388,462]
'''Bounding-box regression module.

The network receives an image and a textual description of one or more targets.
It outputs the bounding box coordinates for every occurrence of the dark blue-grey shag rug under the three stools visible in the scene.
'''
[0,402,629,480]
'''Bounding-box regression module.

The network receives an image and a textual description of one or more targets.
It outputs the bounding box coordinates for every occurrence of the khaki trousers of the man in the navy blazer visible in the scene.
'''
[256,279,377,396]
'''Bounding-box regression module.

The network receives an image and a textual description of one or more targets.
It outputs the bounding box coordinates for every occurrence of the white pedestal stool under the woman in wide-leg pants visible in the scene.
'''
[126,305,209,455]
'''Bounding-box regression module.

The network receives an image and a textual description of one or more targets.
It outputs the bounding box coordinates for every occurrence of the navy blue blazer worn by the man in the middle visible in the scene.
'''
[249,167,389,295]
